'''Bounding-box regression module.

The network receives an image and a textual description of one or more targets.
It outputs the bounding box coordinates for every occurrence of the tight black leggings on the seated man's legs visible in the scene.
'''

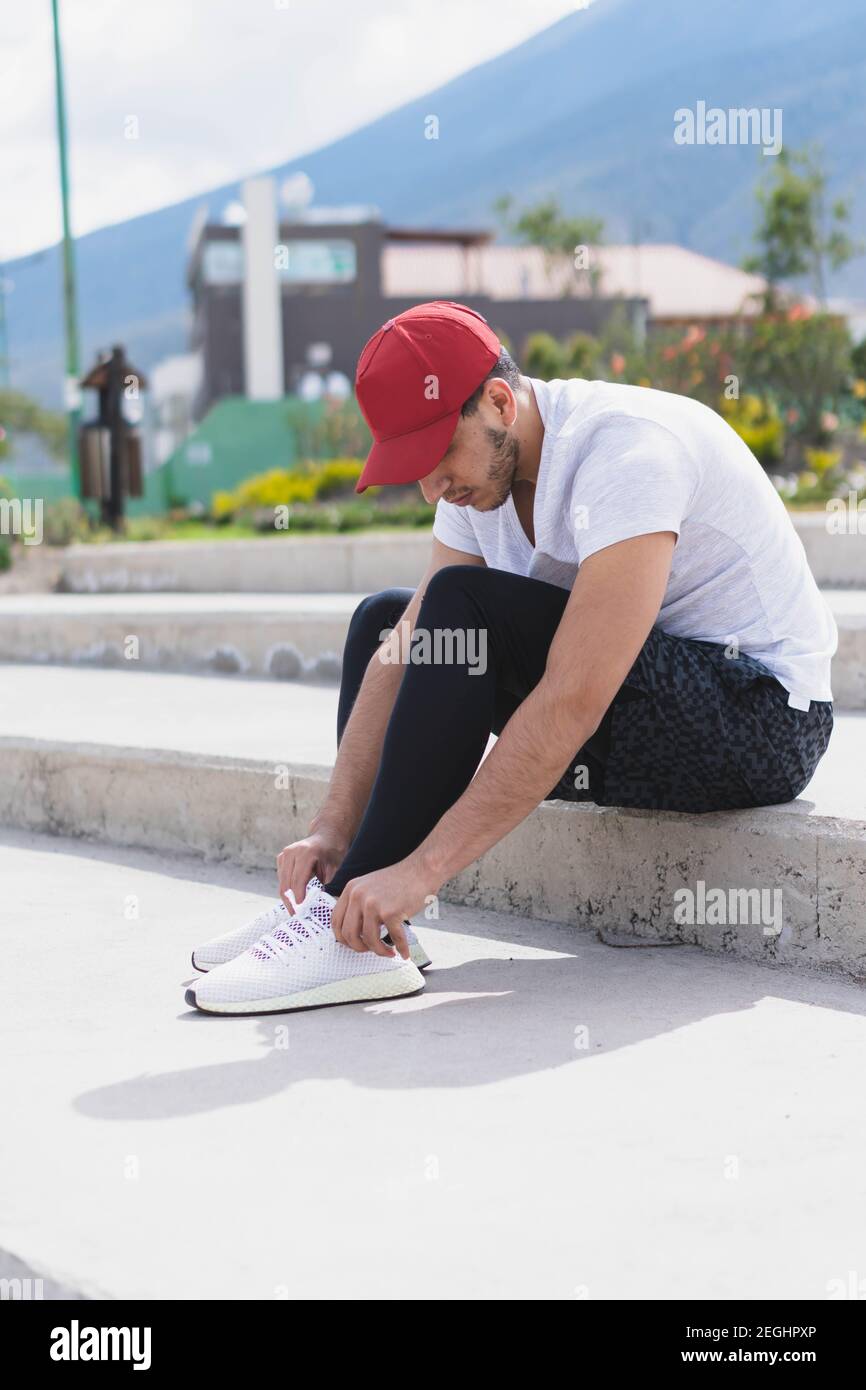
[319,564,610,895]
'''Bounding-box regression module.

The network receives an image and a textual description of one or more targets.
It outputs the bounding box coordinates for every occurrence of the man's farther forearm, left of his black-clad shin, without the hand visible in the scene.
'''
[310,652,405,844]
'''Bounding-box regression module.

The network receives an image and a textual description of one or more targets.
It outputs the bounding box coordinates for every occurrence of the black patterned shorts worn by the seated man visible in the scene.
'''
[550,627,833,812]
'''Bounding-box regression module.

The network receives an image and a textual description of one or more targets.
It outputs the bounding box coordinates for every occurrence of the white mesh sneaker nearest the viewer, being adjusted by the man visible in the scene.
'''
[185,880,424,1013]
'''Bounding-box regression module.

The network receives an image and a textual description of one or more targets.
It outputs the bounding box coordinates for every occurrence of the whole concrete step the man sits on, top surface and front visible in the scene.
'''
[0,666,866,976]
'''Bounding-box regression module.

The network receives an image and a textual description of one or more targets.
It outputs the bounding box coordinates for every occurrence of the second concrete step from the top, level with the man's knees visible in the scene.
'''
[0,589,866,710]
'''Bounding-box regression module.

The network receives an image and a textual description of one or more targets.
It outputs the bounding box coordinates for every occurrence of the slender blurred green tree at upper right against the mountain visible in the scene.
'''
[744,149,863,311]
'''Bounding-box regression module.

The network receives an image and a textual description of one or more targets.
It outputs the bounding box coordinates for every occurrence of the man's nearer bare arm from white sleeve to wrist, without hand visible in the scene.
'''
[410,531,676,884]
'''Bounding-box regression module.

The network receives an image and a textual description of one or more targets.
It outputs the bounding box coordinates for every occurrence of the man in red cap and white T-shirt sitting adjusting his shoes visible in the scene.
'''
[188,302,835,1013]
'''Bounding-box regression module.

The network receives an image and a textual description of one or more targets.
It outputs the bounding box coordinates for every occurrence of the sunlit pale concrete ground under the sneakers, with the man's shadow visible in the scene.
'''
[0,831,866,1302]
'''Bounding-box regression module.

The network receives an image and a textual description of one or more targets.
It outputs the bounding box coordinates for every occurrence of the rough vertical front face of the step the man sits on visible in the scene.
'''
[0,738,866,977]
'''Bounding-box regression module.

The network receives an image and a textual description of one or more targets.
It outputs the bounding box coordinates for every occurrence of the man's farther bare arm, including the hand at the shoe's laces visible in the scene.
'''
[277,537,484,901]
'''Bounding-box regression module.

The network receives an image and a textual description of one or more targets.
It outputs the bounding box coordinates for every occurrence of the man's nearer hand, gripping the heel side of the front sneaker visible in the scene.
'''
[331,855,442,960]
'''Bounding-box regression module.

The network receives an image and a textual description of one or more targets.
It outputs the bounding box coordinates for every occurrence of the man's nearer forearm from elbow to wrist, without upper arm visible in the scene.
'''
[410,680,594,883]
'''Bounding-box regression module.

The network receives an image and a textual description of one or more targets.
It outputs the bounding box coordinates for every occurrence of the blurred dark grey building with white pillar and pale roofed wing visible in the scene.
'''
[188,178,763,420]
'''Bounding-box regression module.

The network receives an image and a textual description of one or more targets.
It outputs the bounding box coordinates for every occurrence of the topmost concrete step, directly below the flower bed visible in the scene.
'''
[52,512,866,594]
